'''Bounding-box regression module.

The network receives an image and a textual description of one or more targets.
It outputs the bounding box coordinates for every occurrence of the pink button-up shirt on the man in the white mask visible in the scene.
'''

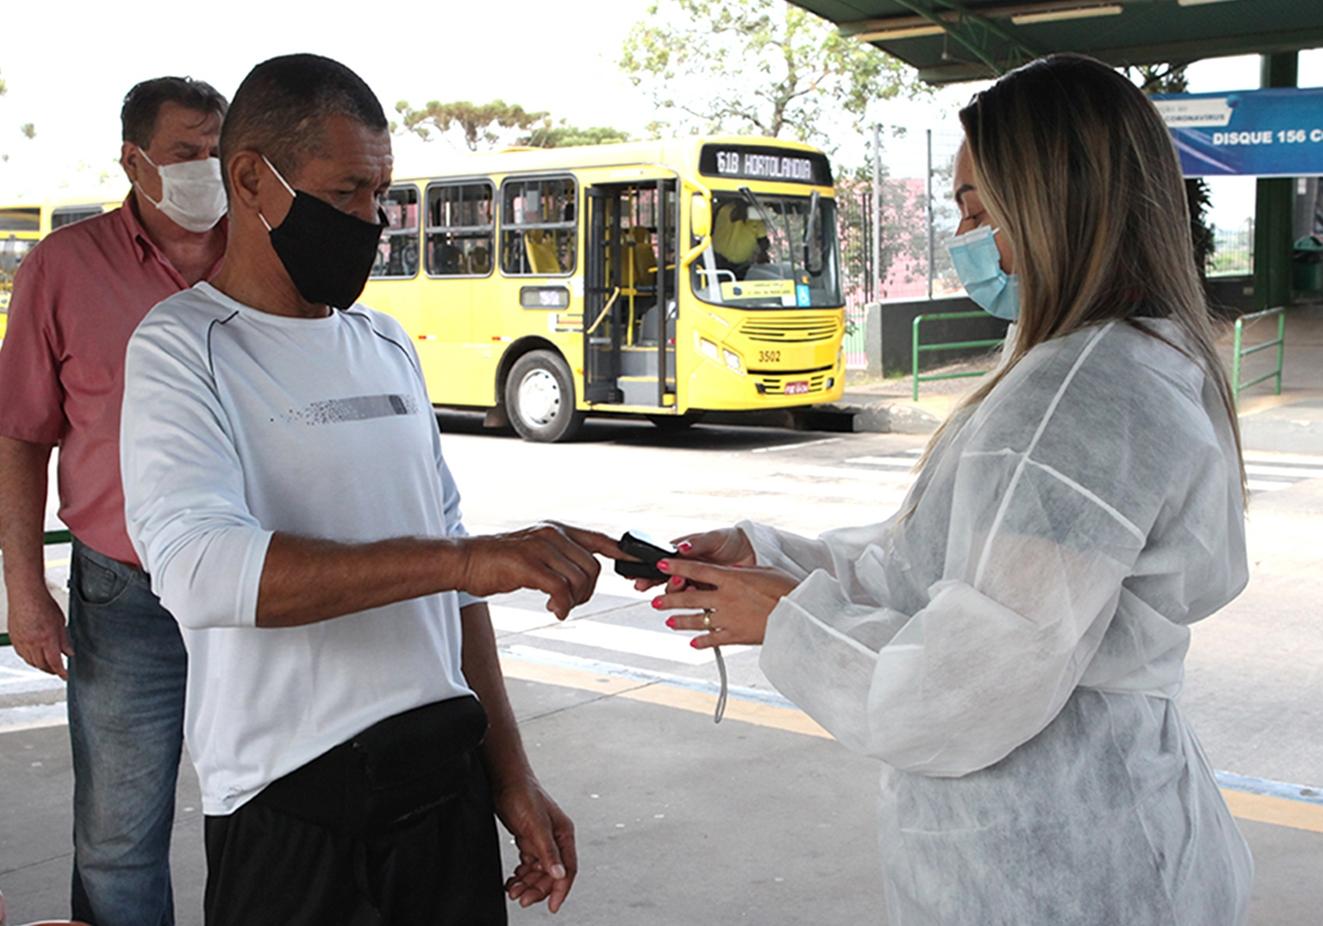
[0,194,224,565]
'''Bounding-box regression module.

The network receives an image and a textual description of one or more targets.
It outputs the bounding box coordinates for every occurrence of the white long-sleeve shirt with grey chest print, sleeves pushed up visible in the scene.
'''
[120,283,472,815]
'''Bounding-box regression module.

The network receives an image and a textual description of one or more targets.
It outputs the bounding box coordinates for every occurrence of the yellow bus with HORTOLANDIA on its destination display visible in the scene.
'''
[363,138,845,441]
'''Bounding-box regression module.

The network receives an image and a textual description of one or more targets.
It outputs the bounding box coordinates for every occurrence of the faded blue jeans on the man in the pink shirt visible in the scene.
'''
[69,538,188,926]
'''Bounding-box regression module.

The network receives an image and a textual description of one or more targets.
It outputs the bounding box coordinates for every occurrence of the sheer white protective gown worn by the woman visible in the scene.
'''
[741,321,1253,926]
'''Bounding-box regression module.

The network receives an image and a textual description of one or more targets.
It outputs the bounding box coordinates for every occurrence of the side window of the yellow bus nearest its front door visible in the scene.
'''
[501,177,578,276]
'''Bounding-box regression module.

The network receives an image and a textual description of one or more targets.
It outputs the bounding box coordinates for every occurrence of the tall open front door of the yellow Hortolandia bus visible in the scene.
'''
[583,177,679,409]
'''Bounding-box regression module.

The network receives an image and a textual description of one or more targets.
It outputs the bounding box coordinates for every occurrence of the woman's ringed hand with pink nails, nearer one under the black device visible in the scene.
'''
[652,552,799,650]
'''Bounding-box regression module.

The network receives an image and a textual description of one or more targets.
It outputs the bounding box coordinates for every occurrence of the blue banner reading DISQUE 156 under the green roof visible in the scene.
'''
[1154,90,1323,177]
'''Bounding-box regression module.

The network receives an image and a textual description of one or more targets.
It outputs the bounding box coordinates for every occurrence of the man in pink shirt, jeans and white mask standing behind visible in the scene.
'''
[0,77,228,926]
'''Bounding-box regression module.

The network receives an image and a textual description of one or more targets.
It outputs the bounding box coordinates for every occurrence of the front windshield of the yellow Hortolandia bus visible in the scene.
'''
[692,187,841,308]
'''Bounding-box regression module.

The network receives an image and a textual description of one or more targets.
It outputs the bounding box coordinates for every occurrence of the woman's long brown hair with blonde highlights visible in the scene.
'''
[925,54,1245,491]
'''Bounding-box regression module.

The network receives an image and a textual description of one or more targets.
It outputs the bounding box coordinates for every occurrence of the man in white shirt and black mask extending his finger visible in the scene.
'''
[120,54,618,926]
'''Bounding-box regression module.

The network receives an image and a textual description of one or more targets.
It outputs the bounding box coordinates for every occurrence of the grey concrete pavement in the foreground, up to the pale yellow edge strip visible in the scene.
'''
[0,656,1323,926]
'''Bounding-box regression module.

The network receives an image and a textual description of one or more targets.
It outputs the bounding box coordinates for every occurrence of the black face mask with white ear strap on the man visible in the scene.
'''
[262,157,386,308]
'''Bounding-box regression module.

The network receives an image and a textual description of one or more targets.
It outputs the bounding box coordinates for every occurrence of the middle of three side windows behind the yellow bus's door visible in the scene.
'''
[427,181,496,276]
